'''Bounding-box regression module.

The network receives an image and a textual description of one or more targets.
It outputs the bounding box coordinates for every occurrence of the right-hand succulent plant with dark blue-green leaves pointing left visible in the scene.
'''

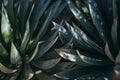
[53,0,120,80]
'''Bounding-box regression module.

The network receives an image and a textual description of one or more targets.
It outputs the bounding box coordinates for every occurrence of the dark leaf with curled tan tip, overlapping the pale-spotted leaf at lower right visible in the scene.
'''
[77,50,112,66]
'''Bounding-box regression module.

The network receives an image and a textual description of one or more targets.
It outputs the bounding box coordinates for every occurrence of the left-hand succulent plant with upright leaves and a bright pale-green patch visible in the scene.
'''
[0,0,66,80]
